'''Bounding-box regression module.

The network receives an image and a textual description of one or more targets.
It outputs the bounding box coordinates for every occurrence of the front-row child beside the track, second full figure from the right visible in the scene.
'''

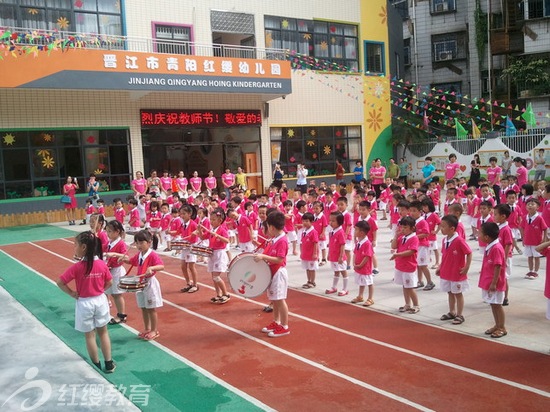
[435,215,472,325]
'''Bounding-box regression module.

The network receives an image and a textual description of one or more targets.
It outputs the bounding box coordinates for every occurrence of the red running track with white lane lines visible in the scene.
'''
[2,239,550,411]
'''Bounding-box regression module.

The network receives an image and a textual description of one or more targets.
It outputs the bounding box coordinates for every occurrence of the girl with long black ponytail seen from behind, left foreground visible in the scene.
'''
[57,231,116,373]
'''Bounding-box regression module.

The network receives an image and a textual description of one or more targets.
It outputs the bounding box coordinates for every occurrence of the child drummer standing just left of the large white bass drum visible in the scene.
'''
[198,207,231,305]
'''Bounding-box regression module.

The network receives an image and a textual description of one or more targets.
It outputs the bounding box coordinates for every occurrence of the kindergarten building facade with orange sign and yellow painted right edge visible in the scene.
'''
[0,0,400,208]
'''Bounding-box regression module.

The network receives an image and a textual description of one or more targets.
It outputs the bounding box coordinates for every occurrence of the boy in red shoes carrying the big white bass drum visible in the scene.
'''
[254,211,290,338]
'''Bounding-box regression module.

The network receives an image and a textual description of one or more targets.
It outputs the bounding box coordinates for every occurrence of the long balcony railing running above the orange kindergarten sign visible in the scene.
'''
[0,27,289,60]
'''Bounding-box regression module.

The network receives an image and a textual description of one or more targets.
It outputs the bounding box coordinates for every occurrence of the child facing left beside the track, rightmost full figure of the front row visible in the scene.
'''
[478,222,508,338]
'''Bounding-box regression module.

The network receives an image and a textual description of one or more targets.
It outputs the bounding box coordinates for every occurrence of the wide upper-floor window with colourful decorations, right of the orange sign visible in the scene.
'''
[264,16,359,72]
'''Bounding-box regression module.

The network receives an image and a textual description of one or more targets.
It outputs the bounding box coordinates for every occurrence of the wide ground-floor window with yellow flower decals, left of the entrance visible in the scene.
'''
[0,129,130,199]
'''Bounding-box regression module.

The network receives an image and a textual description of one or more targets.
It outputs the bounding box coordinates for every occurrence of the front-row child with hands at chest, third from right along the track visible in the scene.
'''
[390,216,420,313]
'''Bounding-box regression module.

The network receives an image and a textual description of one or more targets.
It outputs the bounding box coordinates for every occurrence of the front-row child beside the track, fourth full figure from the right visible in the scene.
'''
[351,219,374,306]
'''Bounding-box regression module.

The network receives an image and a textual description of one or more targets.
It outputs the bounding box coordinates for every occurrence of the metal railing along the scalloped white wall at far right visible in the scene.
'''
[409,128,550,158]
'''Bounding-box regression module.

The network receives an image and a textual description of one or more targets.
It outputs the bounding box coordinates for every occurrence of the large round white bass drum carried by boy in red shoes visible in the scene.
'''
[227,253,271,298]
